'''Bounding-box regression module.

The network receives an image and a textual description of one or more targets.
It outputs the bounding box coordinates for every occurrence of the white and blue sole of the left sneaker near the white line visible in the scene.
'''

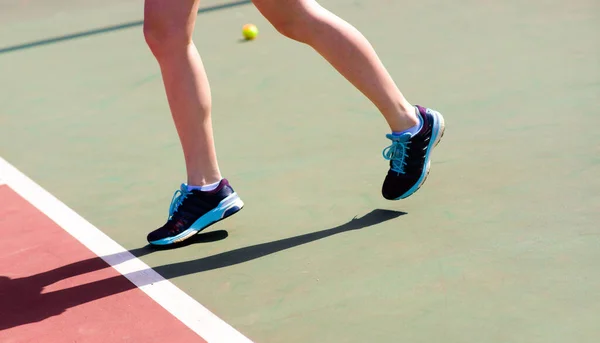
[150,192,244,246]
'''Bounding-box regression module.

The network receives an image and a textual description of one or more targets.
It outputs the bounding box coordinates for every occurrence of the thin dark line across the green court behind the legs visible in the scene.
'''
[0,0,252,54]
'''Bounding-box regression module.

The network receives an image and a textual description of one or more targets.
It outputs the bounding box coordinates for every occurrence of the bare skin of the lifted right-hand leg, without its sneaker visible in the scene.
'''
[253,0,418,132]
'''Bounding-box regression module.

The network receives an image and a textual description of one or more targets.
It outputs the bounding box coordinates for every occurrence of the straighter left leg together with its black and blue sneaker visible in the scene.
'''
[144,0,243,245]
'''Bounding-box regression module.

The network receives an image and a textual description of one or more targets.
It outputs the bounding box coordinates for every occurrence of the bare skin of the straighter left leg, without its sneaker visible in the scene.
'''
[144,0,221,186]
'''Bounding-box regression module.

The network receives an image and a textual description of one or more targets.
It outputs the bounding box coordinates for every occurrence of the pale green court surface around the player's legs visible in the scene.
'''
[0,0,600,343]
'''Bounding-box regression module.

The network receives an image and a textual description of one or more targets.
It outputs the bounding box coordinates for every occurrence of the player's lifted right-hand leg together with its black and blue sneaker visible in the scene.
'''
[253,0,444,200]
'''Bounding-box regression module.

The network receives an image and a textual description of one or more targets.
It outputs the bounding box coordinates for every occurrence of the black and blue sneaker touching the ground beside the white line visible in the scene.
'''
[148,179,244,245]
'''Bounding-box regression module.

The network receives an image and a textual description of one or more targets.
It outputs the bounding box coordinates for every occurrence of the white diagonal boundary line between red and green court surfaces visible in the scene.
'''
[0,157,252,343]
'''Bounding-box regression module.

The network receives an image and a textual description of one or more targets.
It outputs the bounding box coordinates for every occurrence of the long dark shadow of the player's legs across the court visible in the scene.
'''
[0,209,406,330]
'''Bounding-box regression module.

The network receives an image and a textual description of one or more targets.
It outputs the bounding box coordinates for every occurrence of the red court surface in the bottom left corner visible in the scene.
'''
[0,185,205,343]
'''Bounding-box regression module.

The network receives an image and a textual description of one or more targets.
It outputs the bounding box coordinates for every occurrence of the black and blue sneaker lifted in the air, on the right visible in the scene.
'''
[381,106,444,200]
